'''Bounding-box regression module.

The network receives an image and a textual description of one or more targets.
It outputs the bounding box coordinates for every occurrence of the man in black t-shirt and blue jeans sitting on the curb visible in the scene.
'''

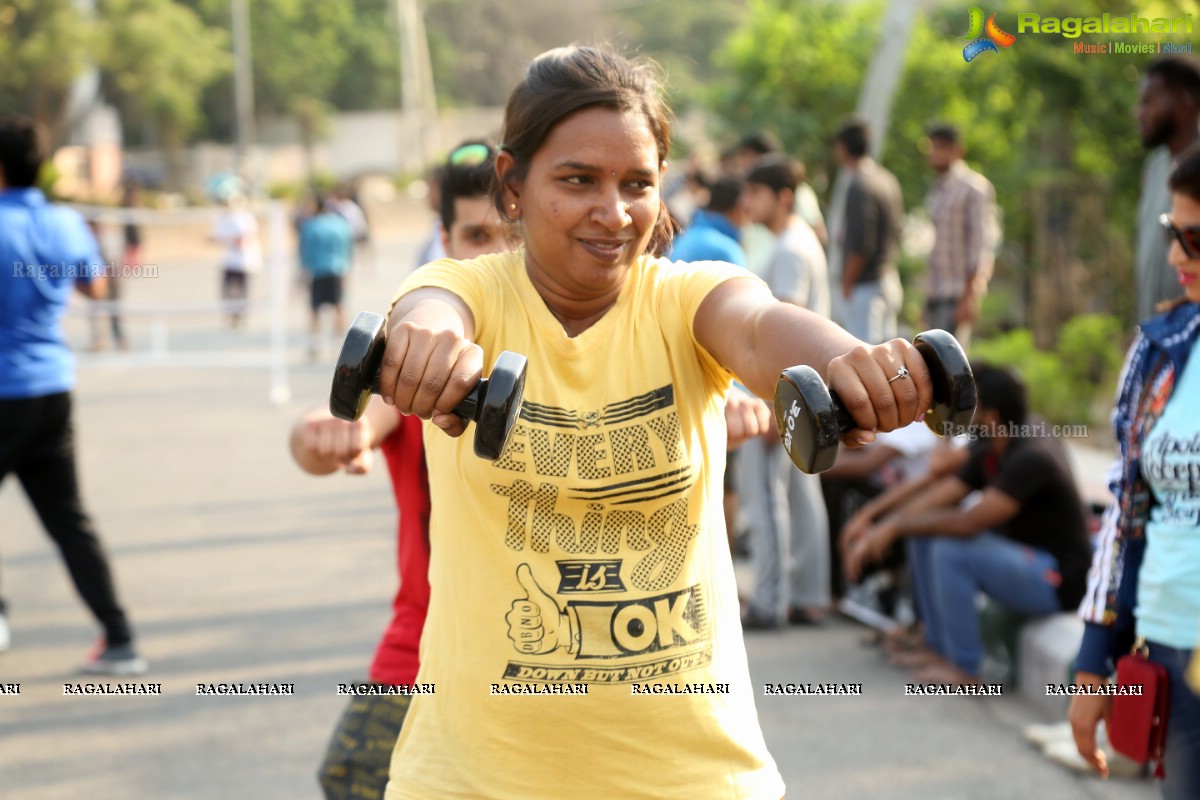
[846,365,1091,684]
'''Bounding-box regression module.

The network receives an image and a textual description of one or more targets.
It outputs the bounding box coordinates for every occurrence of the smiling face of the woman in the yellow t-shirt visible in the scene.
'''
[497,108,661,301]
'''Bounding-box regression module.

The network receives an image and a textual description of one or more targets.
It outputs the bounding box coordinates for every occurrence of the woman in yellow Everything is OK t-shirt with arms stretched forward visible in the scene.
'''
[379,47,931,800]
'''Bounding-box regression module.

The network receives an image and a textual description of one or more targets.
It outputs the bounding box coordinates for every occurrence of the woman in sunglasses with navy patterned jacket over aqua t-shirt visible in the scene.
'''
[1068,142,1200,800]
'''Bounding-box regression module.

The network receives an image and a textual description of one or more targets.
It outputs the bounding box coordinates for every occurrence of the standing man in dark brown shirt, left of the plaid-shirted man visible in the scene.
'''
[833,120,904,344]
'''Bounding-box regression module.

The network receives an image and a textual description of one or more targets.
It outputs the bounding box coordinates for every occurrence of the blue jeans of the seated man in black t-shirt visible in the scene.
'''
[908,531,1061,674]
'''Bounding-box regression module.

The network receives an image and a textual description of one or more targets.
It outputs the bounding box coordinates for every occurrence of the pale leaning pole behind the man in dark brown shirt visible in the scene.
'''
[826,0,924,328]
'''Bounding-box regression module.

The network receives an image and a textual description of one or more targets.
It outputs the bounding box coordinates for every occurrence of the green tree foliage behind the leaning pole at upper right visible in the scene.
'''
[710,0,1194,331]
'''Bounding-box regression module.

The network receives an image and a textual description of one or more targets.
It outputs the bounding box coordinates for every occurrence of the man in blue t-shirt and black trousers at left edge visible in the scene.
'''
[0,116,146,675]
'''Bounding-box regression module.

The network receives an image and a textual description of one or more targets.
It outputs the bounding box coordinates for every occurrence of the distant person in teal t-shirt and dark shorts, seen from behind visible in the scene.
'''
[300,198,354,360]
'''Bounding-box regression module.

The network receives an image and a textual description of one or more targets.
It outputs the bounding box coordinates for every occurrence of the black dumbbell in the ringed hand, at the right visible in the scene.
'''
[775,329,976,474]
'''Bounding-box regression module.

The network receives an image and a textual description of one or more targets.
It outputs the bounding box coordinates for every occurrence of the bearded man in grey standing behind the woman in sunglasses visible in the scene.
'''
[1134,55,1200,321]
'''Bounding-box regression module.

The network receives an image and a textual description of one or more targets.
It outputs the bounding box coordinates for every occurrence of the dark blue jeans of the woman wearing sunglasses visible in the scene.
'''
[1146,642,1200,800]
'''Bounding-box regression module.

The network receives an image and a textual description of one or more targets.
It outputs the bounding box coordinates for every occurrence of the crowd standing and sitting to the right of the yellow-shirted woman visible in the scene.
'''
[657,51,1200,798]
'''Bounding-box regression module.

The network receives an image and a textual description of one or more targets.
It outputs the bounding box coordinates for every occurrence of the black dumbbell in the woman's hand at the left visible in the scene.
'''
[329,311,528,461]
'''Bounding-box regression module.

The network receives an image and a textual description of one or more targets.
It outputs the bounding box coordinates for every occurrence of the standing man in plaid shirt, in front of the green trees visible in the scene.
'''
[925,125,996,347]
